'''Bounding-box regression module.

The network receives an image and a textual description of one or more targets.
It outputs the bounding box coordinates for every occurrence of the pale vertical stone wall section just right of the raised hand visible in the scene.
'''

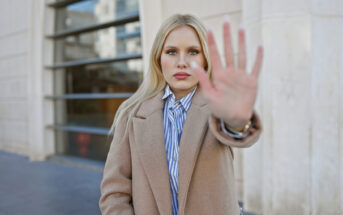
[261,0,312,215]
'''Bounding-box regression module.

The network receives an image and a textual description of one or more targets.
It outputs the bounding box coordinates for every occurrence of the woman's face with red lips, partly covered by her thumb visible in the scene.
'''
[161,26,205,99]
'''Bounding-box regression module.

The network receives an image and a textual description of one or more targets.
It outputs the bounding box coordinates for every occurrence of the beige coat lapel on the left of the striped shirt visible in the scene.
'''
[133,92,172,215]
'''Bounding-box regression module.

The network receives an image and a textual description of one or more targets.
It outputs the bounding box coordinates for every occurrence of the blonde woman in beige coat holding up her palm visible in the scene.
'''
[99,15,262,215]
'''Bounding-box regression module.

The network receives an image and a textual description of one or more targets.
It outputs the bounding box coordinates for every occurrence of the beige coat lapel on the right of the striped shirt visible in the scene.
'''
[179,89,209,215]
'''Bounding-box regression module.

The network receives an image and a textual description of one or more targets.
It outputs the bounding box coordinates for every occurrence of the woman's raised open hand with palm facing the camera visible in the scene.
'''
[192,21,263,130]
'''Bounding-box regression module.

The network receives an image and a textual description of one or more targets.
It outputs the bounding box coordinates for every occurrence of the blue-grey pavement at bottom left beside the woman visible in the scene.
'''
[0,151,102,215]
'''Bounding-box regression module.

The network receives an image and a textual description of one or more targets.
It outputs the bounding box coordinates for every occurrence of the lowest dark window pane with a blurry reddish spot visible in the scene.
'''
[56,131,112,161]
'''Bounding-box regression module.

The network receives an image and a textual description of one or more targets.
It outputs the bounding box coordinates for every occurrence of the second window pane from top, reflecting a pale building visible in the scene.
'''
[55,22,142,63]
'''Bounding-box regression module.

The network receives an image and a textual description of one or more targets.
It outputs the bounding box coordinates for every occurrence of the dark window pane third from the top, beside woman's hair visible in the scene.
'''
[55,59,143,95]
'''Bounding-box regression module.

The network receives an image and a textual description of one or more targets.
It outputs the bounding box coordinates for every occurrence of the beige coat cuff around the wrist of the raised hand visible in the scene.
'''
[209,112,262,148]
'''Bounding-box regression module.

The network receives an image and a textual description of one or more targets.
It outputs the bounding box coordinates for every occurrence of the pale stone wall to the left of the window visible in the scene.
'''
[0,0,53,160]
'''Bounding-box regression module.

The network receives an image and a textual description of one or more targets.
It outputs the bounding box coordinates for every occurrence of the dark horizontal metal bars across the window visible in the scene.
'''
[44,0,143,135]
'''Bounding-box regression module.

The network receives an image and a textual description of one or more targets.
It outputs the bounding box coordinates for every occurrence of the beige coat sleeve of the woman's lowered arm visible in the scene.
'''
[99,116,134,215]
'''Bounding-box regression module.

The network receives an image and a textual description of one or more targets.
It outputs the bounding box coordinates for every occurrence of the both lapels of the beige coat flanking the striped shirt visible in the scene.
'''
[133,87,209,215]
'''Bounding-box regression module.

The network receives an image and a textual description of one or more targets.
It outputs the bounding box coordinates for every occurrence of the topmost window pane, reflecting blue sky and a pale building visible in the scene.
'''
[56,0,138,33]
